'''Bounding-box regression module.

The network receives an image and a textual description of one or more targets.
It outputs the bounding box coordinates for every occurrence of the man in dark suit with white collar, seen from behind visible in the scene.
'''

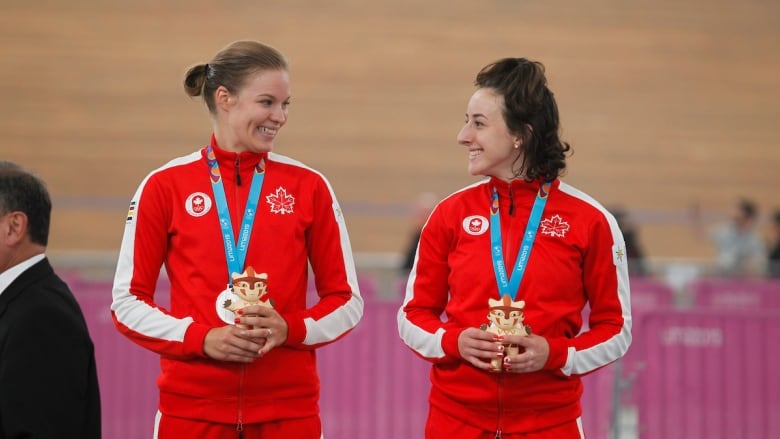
[0,161,100,439]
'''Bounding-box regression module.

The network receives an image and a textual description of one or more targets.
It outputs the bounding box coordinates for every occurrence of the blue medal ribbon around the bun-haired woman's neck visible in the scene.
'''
[206,145,265,284]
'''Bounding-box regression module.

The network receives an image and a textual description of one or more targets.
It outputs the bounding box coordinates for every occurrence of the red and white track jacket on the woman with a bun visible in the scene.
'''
[111,140,363,423]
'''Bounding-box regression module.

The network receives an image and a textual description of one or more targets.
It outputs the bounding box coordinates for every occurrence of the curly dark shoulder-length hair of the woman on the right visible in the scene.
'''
[474,58,571,181]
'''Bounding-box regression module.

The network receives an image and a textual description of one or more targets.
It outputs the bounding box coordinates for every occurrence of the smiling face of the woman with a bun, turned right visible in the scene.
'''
[214,70,290,152]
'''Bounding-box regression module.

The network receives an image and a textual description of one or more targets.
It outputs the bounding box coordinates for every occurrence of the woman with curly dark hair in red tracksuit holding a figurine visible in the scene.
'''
[398,58,631,439]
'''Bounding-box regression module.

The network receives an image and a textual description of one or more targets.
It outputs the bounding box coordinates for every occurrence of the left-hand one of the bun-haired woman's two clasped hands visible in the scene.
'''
[203,325,267,363]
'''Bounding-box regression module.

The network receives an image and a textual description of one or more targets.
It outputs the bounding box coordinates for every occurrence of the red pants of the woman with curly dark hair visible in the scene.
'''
[425,407,585,439]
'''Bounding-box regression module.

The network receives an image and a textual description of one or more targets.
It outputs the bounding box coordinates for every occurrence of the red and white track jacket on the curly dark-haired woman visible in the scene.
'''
[398,179,631,433]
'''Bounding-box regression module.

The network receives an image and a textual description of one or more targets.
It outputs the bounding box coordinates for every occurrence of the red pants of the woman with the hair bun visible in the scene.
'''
[154,412,322,439]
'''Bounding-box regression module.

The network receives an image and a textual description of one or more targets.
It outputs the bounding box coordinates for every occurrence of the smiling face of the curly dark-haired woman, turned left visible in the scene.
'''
[458,88,522,181]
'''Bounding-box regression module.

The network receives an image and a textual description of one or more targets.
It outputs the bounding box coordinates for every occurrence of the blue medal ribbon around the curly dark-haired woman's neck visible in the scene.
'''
[490,182,552,301]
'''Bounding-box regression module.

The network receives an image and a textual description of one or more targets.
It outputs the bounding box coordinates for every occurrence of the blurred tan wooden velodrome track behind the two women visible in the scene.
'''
[0,0,780,270]
